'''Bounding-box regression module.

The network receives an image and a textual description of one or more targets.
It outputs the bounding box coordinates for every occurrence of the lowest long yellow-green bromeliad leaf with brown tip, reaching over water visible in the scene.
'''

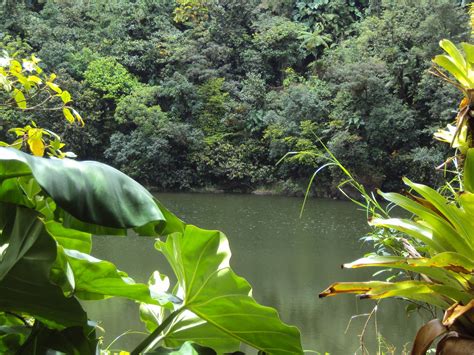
[319,281,474,309]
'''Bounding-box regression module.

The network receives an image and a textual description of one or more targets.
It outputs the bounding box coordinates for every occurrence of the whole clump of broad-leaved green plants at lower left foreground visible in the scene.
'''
[0,148,303,354]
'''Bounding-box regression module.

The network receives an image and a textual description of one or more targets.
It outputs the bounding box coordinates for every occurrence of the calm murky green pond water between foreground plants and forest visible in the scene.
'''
[86,193,421,355]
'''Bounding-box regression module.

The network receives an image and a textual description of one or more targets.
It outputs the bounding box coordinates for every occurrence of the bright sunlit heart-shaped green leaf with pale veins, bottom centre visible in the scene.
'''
[156,225,303,354]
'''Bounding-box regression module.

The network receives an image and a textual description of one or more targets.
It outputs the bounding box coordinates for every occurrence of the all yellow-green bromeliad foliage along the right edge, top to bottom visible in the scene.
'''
[318,27,474,354]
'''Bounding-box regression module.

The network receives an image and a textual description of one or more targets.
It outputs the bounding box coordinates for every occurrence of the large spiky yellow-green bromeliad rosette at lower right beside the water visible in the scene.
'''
[320,163,474,336]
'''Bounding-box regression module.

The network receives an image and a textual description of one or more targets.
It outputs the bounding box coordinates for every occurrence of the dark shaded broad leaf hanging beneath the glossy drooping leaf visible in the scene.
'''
[0,207,87,328]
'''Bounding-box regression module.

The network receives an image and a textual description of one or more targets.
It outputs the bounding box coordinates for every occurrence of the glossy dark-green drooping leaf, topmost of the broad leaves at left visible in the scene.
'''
[0,147,165,234]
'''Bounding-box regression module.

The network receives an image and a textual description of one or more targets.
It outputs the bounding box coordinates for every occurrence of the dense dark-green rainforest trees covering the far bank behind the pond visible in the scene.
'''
[0,0,470,196]
